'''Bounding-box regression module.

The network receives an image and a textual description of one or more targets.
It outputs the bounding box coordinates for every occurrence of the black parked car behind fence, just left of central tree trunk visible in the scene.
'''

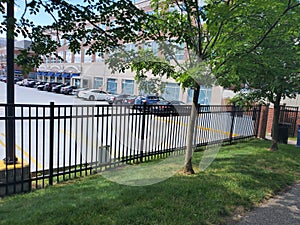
[150,100,186,116]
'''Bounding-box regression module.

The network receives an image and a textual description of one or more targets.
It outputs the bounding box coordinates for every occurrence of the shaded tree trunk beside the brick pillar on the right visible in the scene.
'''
[270,95,281,151]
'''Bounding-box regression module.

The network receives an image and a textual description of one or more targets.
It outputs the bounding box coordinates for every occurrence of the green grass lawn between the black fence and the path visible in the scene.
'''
[0,140,300,225]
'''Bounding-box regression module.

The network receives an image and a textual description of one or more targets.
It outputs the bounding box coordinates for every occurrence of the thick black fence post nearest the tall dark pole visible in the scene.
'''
[49,102,54,185]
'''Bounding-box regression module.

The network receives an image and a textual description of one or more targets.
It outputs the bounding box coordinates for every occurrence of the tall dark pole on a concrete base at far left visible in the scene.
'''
[4,0,18,164]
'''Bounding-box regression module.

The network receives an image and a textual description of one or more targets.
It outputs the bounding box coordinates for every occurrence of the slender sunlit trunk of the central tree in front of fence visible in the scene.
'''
[183,86,200,174]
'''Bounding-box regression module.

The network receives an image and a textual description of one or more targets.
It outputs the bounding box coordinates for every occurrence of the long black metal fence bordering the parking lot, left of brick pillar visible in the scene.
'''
[0,103,261,196]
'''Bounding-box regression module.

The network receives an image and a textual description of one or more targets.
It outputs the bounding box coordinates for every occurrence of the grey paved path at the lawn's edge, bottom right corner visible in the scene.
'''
[236,183,300,225]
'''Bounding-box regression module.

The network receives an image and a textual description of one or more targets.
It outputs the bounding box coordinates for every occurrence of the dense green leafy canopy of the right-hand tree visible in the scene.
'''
[209,0,300,103]
